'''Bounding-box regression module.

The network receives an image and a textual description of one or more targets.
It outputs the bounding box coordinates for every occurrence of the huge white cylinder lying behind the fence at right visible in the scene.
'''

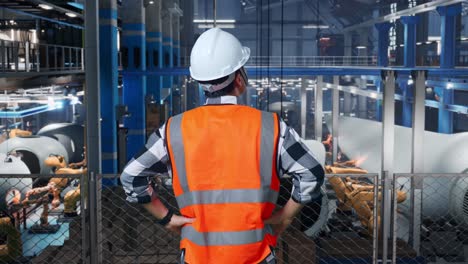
[330,116,468,225]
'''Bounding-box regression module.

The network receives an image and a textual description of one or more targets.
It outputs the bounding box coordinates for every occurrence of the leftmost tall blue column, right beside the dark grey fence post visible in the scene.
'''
[99,0,119,174]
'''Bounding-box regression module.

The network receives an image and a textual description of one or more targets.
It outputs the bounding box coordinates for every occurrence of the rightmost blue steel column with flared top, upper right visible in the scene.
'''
[437,4,462,134]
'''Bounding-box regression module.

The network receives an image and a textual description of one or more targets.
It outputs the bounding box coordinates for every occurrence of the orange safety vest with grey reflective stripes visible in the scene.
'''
[166,105,280,264]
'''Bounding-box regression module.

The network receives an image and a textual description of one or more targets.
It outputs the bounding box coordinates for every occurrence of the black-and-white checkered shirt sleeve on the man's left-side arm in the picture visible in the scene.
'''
[120,126,169,203]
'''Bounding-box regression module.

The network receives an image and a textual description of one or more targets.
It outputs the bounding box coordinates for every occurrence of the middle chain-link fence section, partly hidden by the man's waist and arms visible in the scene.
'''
[97,174,384,264]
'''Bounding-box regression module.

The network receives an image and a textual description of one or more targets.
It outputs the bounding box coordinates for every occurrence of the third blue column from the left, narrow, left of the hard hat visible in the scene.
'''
[146,0,163,105]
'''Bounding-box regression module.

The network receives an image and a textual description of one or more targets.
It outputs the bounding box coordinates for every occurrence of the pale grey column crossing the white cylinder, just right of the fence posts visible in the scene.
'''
[410,71,426,254]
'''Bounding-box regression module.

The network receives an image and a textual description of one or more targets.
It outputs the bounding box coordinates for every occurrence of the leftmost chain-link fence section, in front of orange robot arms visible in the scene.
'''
[0,175,83,263]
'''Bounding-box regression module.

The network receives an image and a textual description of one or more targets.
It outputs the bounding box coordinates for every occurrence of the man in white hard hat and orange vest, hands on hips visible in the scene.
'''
[121,28,324,264]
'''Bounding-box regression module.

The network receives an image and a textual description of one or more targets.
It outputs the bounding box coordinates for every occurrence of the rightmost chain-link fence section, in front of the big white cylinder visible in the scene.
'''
[393,174,468,264]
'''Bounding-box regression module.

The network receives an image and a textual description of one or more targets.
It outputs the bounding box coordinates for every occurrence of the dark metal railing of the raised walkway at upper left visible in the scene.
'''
[0,40,84,73]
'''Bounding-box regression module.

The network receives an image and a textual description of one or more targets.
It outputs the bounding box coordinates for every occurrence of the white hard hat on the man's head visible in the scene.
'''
[190,28,250,81]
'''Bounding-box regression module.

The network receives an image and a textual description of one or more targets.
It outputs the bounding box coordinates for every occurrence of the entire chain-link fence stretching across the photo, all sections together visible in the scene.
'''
[0,174,468,264]
